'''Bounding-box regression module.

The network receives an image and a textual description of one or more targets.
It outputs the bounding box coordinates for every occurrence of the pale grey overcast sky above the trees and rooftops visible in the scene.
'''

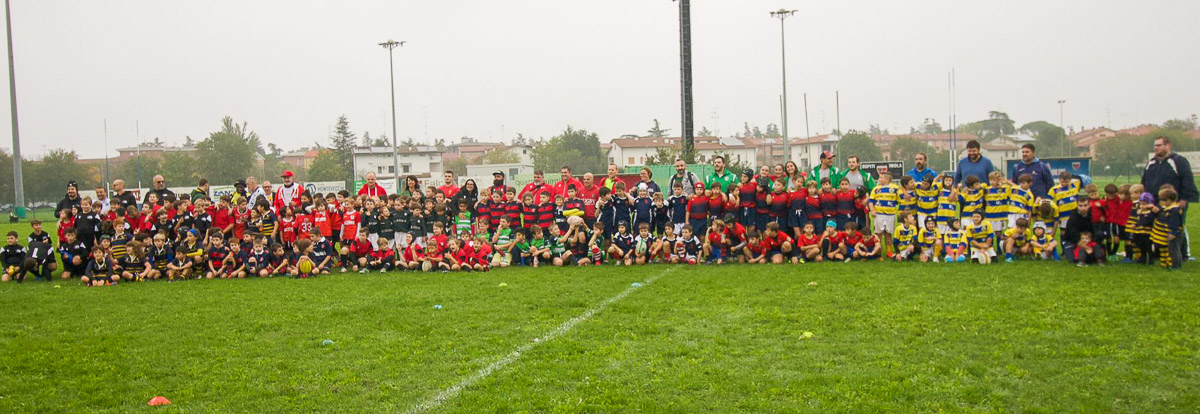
[0,0,1200,157]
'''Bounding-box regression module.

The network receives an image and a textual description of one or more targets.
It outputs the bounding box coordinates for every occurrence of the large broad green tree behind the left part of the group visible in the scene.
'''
[195,116,260,182]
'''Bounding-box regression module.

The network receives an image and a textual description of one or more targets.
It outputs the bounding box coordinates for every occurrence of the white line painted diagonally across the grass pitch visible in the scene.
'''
[407,266,678,414]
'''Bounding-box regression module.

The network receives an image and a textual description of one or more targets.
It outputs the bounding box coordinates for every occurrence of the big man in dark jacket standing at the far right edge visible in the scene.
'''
[1141,137,1200,259]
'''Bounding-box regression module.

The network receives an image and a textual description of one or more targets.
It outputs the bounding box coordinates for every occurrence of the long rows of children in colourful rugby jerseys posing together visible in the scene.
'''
[0,170,1182,286]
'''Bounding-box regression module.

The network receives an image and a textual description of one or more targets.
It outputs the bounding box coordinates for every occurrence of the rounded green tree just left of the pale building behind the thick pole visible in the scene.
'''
[533,126,608,174]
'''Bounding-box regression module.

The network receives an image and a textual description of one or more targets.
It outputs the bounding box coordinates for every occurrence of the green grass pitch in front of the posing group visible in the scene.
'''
[0,212,1200,413]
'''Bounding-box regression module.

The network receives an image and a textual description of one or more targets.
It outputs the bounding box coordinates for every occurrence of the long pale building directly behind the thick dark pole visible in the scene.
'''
[608,137,755,168]
